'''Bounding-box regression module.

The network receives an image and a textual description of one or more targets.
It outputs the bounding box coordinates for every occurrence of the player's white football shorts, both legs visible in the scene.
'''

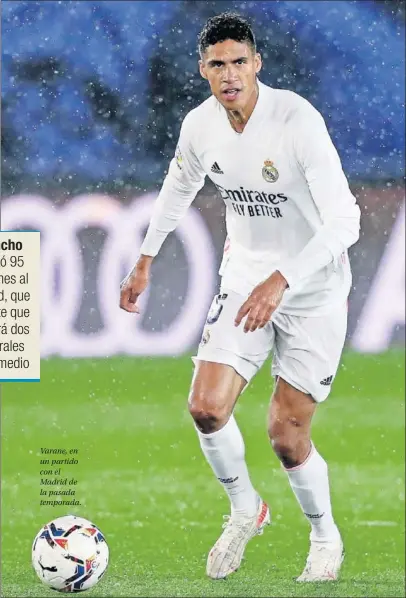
[193,290,347,403]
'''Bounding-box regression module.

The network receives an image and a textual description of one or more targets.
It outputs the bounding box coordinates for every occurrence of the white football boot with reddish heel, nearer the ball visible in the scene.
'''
[206,497,271,579]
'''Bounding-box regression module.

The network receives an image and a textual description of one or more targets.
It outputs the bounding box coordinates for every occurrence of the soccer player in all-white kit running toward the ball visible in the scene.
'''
[120,13,360,582]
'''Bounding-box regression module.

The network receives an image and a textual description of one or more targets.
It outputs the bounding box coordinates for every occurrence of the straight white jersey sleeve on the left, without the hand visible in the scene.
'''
[140,113,205,256]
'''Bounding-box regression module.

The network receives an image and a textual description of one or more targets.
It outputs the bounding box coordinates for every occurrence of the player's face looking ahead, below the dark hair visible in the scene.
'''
[199,39,261,110]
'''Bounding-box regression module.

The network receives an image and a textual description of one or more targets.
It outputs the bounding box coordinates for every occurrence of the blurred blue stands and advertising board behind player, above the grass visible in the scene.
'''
[2,0,405,356]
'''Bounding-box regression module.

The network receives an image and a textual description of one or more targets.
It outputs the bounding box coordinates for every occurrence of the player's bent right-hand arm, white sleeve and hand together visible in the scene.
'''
[235,103,360,332]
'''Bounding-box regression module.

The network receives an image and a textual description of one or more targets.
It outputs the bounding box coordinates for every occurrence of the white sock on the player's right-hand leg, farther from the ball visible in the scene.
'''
[285,444,340,542]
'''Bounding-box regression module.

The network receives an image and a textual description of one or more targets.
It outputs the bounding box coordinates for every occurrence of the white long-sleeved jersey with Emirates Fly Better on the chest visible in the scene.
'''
[141,82,360,316]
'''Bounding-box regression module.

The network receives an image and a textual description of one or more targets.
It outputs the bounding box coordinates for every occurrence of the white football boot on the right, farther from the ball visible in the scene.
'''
[296,538,344,582]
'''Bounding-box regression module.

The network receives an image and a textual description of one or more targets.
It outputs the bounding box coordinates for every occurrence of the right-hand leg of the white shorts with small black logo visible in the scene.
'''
[272,304,347,403]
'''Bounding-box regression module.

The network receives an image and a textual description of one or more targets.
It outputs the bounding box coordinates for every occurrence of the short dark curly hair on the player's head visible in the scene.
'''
[198,12,256,56]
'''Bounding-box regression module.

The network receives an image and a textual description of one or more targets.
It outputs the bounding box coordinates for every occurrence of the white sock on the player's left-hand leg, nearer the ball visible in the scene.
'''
[196,415,258,517]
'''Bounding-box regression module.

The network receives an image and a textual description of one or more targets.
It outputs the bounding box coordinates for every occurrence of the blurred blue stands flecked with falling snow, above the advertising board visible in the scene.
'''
[2,1,404,196]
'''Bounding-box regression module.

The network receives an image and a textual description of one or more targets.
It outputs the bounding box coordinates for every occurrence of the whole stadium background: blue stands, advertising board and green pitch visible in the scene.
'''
[1,0,405,596]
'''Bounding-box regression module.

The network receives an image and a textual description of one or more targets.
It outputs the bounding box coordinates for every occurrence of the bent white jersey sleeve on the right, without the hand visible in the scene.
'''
[278,103,360,289]
